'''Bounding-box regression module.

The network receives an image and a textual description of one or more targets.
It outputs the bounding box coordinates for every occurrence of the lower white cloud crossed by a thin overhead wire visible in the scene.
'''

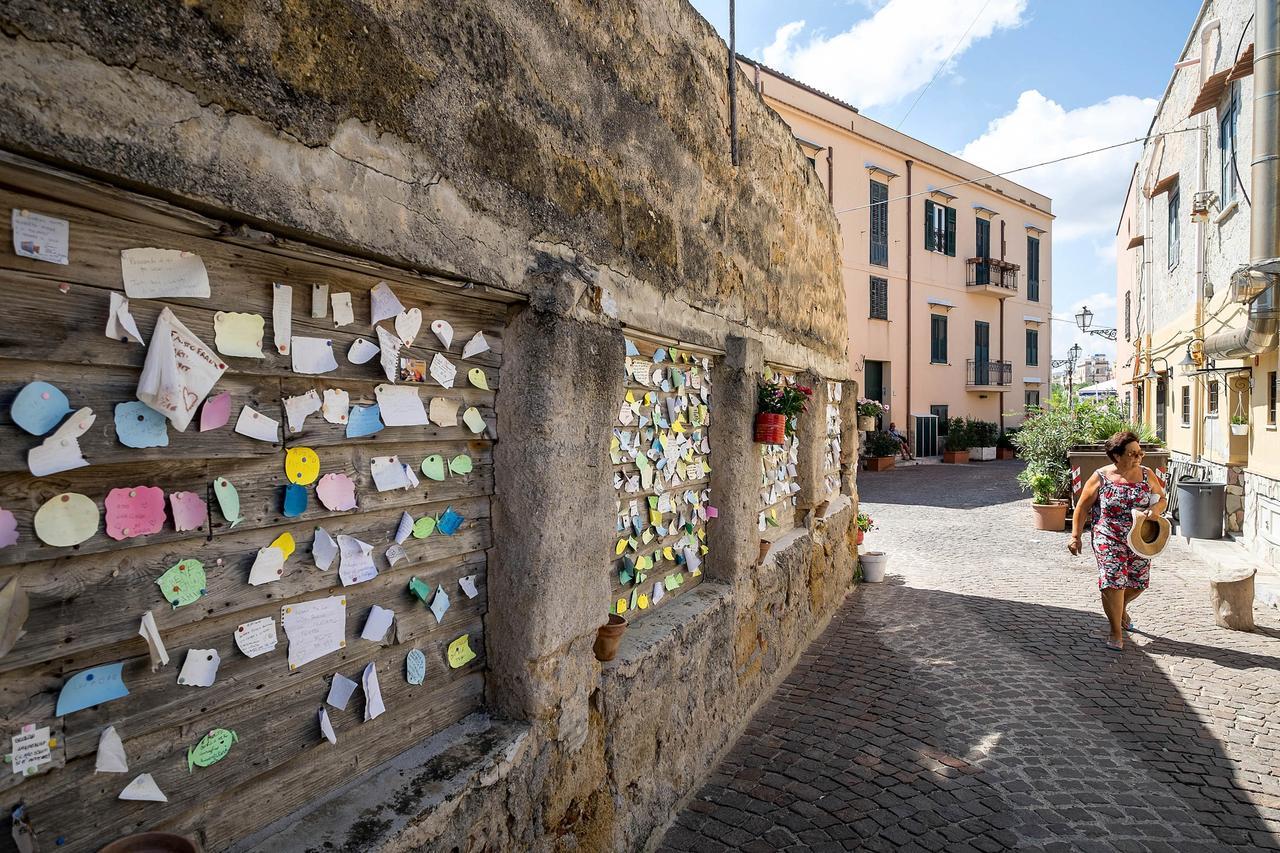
[957,90,1156,242]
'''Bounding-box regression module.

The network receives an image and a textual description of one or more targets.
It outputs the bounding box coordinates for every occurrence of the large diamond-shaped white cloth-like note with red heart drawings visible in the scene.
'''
[137,307,227,433]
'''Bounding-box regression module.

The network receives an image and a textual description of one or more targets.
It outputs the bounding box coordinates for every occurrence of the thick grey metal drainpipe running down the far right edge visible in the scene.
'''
[1204,0,1280,359]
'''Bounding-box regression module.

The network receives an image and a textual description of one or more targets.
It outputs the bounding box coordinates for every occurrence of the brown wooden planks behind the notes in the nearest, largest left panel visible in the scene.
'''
[0,160,509,850]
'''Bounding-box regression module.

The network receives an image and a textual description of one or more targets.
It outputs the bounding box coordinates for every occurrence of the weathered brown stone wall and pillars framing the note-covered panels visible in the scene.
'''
[0,0,858,850]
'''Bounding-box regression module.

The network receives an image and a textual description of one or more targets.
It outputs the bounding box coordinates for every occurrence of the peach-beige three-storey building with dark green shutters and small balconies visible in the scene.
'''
[740,58,1053,456]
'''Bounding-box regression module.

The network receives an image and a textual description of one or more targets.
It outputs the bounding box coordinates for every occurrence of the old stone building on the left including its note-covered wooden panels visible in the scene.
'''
[0,0,860,850]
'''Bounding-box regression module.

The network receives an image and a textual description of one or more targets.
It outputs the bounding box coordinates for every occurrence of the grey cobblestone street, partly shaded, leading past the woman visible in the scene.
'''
[660,462,1280,853]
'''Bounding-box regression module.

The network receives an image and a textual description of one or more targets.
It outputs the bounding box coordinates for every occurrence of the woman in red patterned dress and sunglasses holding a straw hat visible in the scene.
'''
[1068,432,1167,652]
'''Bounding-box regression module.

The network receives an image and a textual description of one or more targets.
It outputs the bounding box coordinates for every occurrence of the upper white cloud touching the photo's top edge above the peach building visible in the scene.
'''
[763,0,1027,108]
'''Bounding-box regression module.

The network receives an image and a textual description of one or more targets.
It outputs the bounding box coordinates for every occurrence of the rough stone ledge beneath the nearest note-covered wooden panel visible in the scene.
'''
[230,713,530,853]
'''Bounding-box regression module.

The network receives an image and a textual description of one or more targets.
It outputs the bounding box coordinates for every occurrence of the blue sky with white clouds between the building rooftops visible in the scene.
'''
[692,0,1201,357]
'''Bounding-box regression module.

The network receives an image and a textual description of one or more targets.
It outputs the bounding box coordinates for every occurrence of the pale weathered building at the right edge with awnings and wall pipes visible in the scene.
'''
[1116,0,1280,561]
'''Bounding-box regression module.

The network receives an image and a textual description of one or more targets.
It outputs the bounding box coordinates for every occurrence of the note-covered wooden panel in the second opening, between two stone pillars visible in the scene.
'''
[608,329,714,621]
